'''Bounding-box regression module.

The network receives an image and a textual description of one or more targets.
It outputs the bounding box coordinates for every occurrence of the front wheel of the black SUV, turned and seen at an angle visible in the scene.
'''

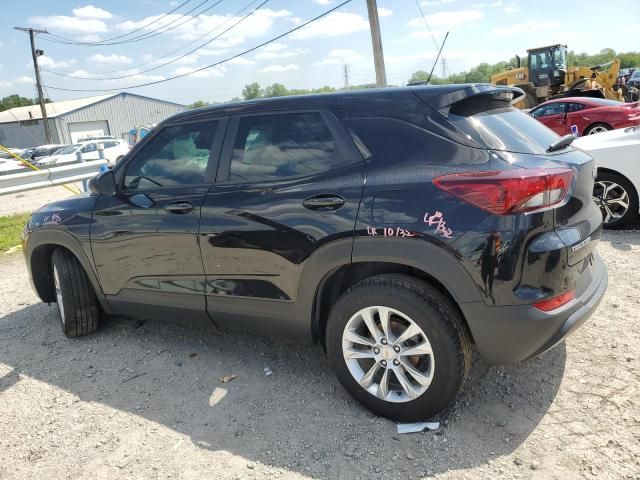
[51,248,100,337]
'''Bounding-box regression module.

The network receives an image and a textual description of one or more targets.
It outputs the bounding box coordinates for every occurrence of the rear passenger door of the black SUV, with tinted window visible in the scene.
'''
[200,111,365,335]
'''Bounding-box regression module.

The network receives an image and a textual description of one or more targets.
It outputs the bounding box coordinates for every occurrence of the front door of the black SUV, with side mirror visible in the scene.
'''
[91,118,227,316]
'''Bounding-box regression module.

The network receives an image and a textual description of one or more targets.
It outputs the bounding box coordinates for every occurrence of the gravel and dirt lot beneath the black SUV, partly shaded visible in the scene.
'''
[0,227,640,479]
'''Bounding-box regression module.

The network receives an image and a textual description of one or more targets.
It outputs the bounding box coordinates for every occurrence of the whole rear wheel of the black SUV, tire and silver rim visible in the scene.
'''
[326,274,471,422]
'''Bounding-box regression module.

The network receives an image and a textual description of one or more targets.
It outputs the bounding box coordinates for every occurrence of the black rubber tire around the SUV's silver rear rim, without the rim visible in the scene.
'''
[326,274,472,422]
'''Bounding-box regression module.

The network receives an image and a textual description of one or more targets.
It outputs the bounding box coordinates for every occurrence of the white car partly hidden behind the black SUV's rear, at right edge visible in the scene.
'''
[572,126,640,228]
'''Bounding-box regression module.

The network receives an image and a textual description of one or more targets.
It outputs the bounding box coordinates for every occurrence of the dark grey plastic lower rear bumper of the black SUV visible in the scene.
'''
[460,252,608,365]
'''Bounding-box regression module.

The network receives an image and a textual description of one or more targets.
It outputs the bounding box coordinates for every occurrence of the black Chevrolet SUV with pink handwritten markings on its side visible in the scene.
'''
[24,85,607,421]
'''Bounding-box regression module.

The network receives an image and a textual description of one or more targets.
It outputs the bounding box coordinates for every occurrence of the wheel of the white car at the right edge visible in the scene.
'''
[593,172,638,229]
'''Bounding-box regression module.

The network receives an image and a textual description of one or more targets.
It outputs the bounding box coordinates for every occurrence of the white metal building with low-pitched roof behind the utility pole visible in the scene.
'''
[0,92,187,147]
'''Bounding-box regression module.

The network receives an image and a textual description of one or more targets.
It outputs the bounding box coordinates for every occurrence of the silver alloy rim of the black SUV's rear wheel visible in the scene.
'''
[342,306,435,403]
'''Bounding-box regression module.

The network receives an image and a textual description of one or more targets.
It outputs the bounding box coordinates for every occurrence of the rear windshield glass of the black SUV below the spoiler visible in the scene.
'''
[448,107,559,154]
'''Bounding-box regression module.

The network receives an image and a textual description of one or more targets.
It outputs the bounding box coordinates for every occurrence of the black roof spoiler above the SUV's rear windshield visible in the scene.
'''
[414,83,525,117]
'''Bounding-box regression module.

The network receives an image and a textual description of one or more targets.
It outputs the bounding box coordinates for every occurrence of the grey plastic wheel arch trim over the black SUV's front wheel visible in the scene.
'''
[25,230,110,312]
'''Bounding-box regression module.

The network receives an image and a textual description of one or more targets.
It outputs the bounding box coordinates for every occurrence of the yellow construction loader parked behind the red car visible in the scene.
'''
[491,44,624,108]
